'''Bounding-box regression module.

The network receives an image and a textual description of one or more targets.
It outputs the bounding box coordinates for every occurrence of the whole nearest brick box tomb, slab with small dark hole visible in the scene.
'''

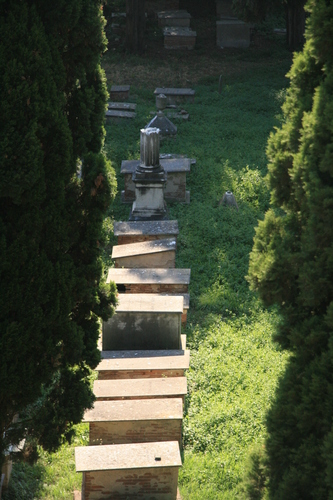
[75,441,181,500]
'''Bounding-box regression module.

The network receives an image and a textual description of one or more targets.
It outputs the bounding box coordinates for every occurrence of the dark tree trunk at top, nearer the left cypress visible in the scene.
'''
[126,0,145,53]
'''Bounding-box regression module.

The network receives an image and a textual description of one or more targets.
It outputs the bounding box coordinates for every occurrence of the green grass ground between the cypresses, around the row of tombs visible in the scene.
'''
[4,15,291,500]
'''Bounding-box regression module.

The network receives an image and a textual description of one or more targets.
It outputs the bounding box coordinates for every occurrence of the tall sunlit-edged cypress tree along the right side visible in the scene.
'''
[249,0,333,500]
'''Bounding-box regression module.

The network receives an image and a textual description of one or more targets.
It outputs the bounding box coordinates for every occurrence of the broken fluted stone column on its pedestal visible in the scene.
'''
[129,128,167,220]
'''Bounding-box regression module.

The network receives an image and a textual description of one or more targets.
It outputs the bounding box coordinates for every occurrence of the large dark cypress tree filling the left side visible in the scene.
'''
[0,0,116,464]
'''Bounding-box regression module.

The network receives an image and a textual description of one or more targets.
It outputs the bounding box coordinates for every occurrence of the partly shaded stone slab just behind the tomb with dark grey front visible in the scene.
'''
[107,268,191,285]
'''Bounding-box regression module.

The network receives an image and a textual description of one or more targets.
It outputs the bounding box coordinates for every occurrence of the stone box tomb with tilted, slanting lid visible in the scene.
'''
[112,238,177,268]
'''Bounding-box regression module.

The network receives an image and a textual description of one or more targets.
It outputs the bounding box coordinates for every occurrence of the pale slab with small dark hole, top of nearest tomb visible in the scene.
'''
[75,441,182,472]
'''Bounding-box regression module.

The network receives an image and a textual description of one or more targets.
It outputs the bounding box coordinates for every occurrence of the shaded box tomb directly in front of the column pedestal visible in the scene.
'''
[113,220,179,245]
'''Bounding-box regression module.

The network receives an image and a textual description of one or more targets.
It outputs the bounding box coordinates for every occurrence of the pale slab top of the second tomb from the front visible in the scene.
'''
[83,398,183,422]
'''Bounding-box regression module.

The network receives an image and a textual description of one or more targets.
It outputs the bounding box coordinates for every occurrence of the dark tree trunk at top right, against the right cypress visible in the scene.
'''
[286,0,305,51]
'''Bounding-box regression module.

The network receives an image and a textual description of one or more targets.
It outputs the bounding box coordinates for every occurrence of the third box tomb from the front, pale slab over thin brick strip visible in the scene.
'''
[94,377,187,405]
